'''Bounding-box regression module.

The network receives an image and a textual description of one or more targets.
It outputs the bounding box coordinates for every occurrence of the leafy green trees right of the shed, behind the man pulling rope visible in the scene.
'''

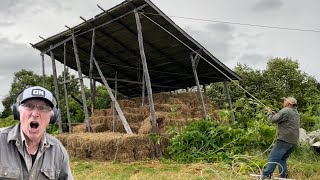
[208,58,320,130]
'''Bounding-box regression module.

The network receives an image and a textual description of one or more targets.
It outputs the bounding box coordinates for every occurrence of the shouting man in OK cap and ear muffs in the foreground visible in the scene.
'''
[0,86,73,179]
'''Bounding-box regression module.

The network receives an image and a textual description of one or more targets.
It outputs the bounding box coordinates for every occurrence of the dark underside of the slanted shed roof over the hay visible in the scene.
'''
[33,0,240,97]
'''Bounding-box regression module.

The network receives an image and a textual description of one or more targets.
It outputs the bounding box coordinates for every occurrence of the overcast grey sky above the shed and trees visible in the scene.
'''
[0,0,320,112]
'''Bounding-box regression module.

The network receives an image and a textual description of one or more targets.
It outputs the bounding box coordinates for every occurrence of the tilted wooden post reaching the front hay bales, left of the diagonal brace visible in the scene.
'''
[72,33,91,132]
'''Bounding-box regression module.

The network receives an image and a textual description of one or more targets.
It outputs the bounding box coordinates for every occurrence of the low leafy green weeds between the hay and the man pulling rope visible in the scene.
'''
[166,97,275,162]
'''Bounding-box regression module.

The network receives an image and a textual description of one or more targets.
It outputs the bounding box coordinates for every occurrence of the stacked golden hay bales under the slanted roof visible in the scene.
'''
[57,92,219,162]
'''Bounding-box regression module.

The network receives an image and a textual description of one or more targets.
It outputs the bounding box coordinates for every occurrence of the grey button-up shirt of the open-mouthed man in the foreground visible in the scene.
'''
[0,124,73,180]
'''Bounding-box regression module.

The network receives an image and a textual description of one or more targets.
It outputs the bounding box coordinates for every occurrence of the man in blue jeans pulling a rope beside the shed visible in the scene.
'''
[262,97,300,179]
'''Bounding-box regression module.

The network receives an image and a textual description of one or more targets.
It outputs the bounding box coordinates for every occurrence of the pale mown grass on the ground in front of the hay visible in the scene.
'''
[71,157,320,180]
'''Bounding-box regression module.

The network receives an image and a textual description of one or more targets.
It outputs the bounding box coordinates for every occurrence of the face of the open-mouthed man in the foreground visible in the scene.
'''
[20,99,52,141]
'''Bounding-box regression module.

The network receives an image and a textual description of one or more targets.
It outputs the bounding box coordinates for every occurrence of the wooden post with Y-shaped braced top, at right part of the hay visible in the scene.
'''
[190,53,208,119]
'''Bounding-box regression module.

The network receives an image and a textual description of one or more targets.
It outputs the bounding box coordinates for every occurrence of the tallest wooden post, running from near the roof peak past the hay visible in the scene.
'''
[134,10,160,156]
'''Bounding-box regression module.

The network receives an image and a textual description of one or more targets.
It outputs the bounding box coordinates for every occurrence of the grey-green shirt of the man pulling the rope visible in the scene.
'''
[268,107,300,144]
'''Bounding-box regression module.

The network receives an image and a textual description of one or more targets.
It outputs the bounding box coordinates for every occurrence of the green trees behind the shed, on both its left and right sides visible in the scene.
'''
[1,58,320,129]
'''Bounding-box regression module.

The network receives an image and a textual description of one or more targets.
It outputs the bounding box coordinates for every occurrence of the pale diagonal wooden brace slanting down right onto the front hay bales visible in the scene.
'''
[93,57,133,134]
